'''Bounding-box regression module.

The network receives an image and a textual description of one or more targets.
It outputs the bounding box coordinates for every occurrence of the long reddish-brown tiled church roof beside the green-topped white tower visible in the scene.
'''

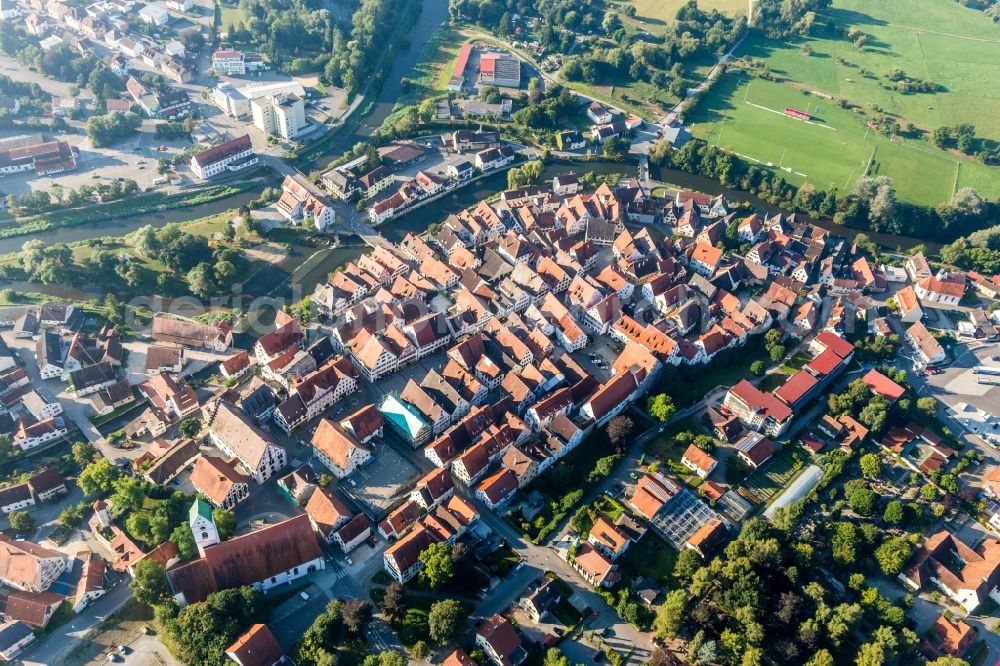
[167,514,322,603]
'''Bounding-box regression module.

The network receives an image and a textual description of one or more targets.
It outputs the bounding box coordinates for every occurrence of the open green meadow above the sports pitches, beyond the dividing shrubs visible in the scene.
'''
[737,0,1000,139]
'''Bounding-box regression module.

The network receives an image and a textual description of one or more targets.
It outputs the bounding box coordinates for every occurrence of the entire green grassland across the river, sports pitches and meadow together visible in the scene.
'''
[688,0,1000,205]
